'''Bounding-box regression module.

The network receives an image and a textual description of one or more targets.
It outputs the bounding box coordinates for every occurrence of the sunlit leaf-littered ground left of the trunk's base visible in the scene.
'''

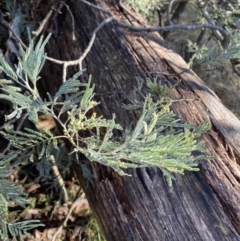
[9,163,104,241]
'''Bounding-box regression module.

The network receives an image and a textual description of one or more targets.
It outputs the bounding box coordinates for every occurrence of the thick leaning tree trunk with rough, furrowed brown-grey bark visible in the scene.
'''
[36,0,240,241]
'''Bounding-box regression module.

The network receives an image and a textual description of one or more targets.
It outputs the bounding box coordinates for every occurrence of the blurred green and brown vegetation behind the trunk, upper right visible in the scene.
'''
[126,0,240,117]
